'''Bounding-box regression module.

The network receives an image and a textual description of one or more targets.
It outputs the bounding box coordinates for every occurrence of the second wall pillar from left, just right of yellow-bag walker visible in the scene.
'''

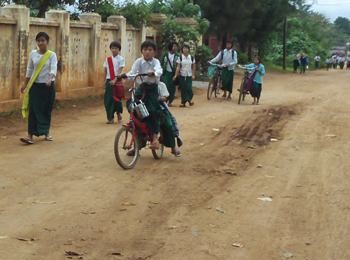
[45,10,70,98]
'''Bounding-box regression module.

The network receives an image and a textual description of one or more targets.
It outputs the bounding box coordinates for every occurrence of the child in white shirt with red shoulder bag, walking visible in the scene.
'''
[103,41,125,124]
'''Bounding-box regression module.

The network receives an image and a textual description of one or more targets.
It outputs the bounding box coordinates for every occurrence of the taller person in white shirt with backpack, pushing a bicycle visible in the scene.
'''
[210,41,237,100]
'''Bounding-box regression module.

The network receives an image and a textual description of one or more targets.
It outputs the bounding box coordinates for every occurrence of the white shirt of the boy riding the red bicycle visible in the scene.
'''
[126,57,163,85]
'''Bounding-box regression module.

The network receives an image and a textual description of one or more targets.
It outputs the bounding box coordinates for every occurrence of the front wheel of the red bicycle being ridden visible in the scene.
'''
[114,126,140,170]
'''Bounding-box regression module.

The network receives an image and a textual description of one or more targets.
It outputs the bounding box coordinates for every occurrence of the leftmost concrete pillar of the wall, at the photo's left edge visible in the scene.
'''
[0,5,29,99]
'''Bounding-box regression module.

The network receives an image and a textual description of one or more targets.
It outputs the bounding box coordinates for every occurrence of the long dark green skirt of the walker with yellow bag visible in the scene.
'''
[28,82,56,136]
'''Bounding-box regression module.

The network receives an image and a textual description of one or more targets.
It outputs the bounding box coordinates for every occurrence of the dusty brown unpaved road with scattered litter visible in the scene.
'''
[0,71,350,260]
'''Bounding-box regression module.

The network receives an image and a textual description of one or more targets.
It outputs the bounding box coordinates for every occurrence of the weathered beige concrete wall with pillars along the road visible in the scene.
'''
[0,5,155,112]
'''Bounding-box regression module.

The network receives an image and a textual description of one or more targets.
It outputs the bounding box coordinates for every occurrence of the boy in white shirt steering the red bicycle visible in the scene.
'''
[123,41,163,150]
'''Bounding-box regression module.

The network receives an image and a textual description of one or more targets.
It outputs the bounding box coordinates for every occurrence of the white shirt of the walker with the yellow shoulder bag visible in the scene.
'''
[26,50,57,83]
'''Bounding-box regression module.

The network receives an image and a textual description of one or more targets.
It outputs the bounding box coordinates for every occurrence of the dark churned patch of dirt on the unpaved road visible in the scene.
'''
[231,106,297,146]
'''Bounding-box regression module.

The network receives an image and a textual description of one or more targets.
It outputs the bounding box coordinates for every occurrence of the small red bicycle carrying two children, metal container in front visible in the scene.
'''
[114,74,164,170]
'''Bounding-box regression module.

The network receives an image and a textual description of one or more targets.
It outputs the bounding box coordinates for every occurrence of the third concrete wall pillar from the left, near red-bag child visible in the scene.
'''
[79,13,101,87]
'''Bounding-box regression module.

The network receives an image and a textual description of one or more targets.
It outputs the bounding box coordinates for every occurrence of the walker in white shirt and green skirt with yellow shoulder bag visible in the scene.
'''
[20,32,57,144]
